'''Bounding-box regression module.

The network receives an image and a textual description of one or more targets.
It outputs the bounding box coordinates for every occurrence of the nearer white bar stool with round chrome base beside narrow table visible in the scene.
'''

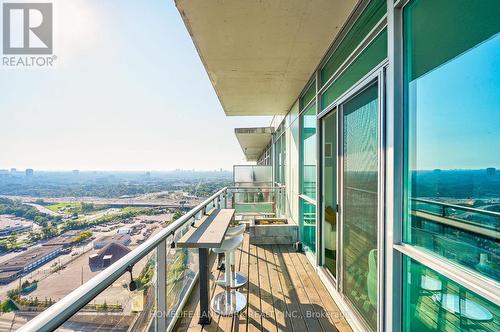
[211,234,247,316]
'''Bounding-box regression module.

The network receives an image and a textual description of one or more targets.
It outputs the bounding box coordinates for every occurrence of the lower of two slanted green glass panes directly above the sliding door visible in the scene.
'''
[321,30,387,109]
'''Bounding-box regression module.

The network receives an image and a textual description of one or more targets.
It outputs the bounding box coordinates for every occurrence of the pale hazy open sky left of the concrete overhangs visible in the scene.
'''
[0,0,271,170]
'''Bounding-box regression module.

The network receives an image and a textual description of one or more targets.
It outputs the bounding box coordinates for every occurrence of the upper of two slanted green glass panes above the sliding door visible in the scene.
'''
[321,0,387,86]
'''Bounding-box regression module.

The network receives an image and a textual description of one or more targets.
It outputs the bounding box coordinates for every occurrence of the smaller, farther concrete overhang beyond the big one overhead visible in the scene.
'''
[234,127,273,161]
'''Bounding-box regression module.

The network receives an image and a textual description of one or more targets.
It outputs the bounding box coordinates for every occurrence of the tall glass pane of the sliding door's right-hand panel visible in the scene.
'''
[342,83,378,330]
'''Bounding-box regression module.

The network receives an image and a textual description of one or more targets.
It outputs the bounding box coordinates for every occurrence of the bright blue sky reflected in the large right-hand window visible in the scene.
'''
[410,34,500,170]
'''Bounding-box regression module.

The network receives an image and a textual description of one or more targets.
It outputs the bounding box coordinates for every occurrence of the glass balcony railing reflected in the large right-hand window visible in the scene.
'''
[405,198,500,280]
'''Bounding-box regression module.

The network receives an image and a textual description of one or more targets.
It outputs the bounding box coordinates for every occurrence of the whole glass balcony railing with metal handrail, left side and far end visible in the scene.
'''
[15,187,284,331]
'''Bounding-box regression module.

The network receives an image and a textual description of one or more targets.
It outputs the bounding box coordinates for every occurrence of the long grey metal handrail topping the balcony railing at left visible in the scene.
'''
[18,187,227,332]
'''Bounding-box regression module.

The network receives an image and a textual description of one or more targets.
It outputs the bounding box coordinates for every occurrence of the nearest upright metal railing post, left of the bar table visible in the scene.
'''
[156,240,168,332]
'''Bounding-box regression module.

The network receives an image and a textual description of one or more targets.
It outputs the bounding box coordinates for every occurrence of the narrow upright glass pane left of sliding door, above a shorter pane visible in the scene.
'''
[301,103,316,199]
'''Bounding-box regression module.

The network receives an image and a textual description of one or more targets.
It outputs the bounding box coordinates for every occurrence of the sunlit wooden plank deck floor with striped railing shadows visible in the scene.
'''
[175,235,352,332]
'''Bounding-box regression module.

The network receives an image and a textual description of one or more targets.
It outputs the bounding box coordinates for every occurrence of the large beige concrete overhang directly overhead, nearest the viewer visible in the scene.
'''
[175,0,358,115]
